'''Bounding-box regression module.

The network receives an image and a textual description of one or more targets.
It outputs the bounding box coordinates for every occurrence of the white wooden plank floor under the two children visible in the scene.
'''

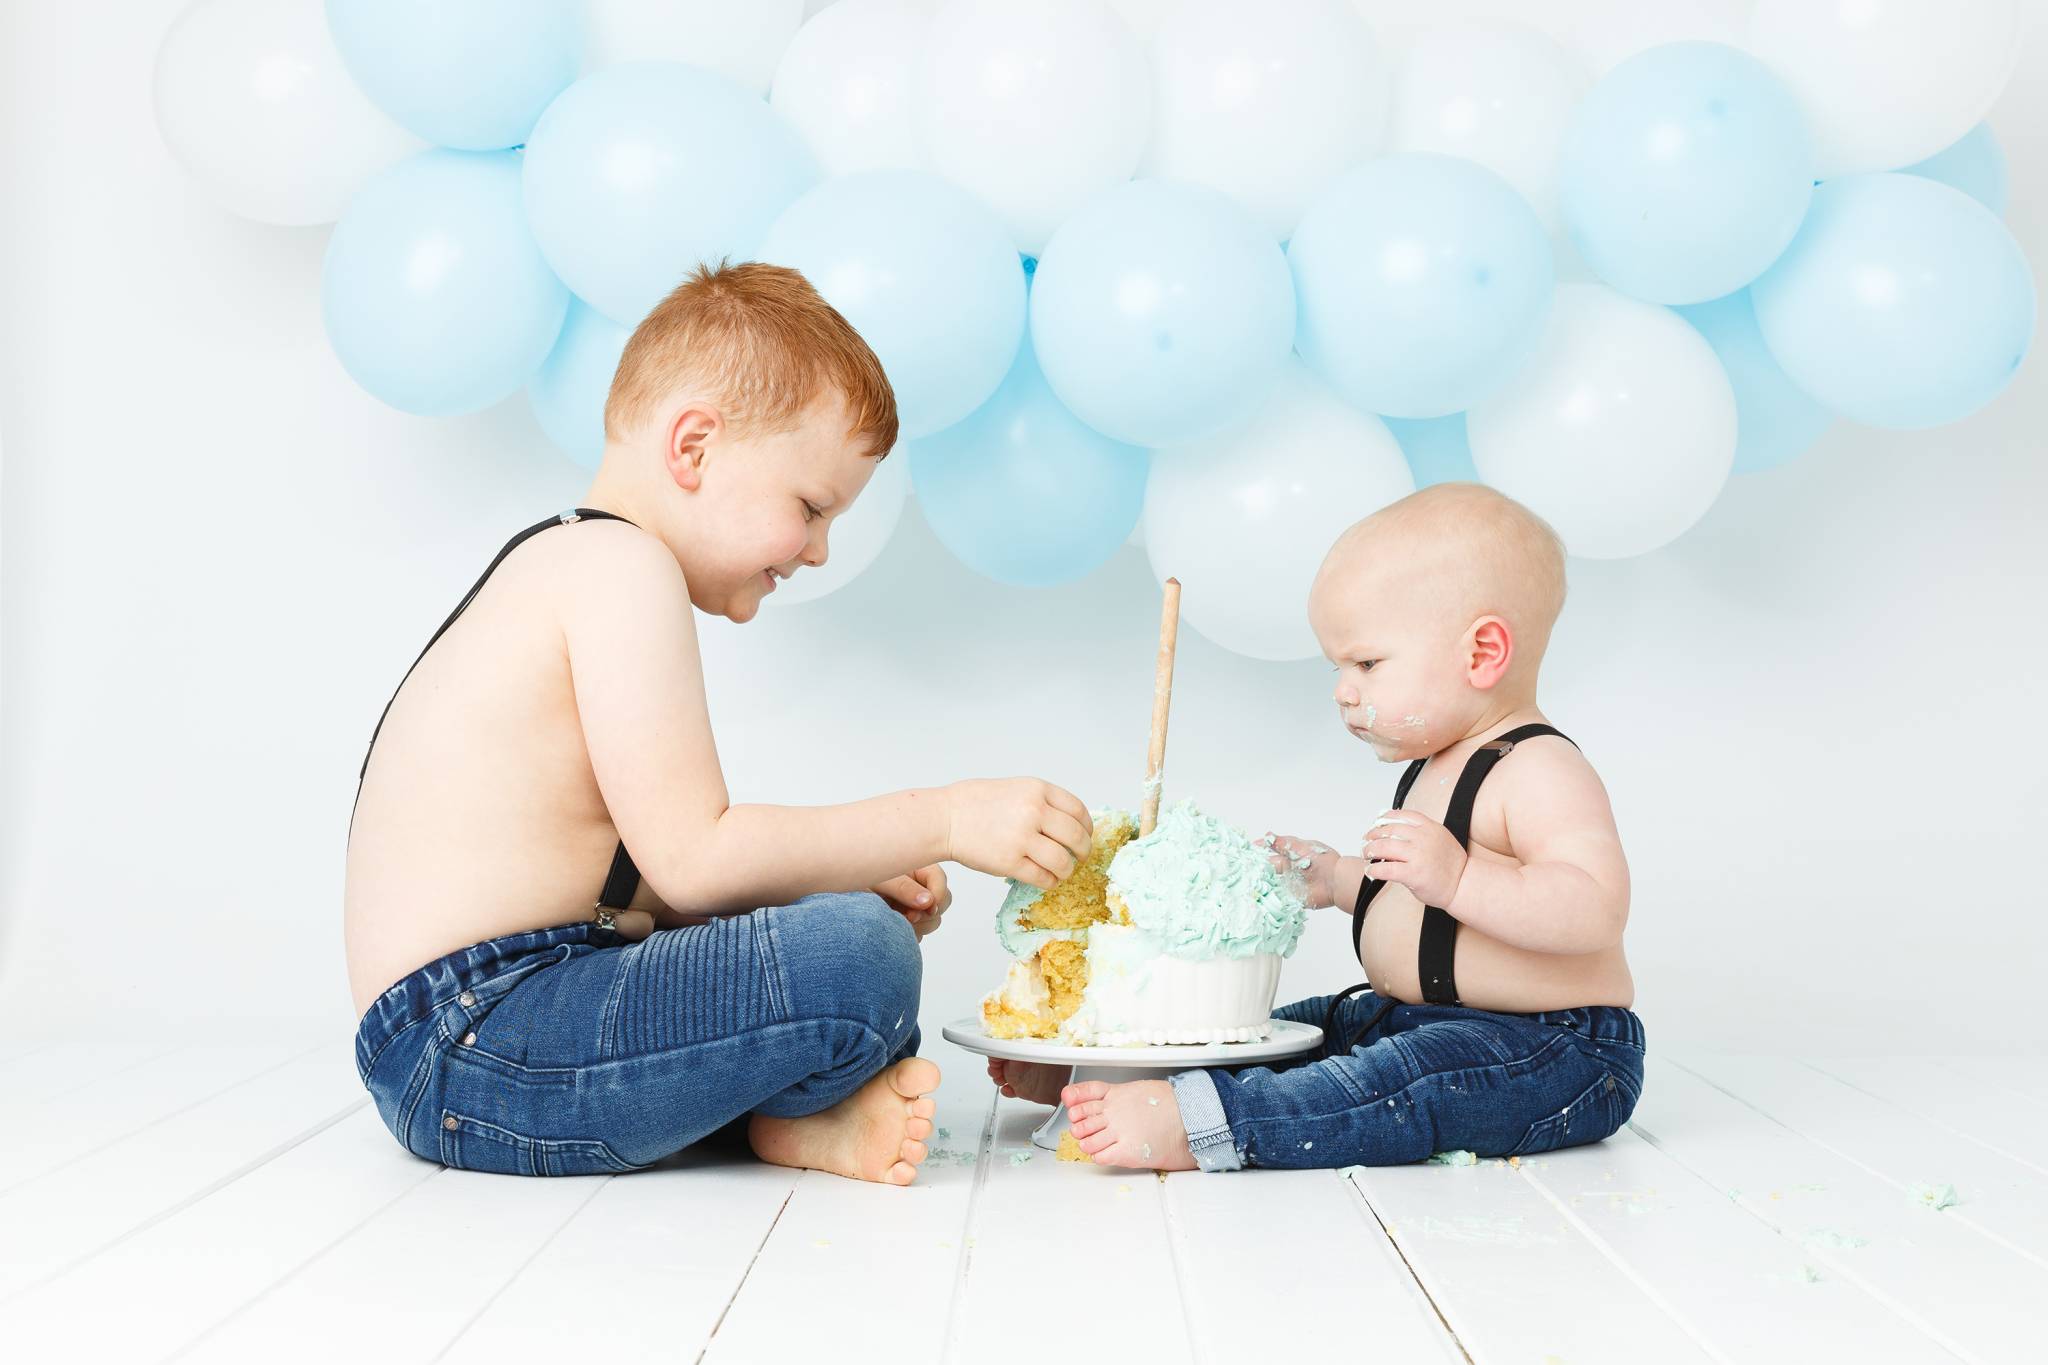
[0,1040,2048,1365]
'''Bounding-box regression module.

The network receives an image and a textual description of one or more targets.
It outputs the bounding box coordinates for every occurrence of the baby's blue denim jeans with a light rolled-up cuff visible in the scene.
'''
[1171,990,1642,1171]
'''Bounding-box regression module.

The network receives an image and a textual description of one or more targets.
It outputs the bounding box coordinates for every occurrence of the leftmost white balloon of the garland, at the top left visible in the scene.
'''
[156,0,426,227]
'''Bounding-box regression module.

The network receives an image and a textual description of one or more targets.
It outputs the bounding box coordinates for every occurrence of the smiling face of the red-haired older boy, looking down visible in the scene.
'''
[684,397,876,622]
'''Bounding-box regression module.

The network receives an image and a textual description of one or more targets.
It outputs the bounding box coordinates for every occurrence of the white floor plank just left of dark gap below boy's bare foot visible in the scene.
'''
[442,1152,797,1365]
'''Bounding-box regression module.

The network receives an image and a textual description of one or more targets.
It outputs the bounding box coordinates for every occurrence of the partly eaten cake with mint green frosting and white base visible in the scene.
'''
[981,800,1309,1048]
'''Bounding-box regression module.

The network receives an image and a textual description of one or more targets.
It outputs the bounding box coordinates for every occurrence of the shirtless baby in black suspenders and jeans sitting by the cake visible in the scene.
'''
[989,483,1642,1171]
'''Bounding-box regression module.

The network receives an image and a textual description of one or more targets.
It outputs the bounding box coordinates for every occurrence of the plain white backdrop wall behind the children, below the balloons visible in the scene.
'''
[0,0,2048,1052]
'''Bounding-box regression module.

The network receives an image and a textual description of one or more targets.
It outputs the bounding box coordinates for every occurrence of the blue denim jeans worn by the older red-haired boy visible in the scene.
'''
[356,892,924,1175]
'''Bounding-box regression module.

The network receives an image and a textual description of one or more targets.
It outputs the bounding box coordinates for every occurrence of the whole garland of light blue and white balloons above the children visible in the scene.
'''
[156,0,2036,659]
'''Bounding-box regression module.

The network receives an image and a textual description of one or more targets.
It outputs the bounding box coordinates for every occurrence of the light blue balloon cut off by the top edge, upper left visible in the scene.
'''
[328,0,584,151]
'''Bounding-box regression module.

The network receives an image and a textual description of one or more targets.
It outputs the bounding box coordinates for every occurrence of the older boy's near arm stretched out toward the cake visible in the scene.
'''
[553,524,1090,915]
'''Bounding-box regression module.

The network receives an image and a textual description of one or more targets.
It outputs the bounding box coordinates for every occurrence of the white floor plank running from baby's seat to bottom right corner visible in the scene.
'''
[1630,1054,2048,1365]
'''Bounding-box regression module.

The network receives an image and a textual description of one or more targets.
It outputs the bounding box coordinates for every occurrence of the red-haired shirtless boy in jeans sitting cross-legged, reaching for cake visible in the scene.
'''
[344,264,1090,1185]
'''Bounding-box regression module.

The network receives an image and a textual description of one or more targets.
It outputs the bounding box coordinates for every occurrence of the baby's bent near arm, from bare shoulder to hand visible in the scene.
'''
[1354,749,1628,954]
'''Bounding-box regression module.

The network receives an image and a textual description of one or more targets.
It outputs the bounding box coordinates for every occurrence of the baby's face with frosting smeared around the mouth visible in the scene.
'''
[1309,565,1475,763]
